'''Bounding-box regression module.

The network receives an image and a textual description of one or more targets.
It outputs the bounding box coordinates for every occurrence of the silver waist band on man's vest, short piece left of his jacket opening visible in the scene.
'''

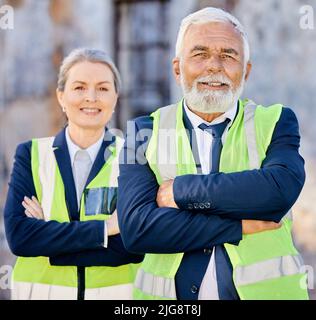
[134,268,177,299]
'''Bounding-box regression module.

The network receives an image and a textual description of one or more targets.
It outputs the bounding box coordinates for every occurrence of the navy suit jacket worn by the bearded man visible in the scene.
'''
[117,102,305,299]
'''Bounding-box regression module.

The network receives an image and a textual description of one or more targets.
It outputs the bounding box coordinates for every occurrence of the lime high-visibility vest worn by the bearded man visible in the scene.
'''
[134,100,308,300]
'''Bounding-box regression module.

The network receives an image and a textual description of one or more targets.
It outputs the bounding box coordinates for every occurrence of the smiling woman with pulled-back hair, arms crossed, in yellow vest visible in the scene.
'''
[5,49,142,300]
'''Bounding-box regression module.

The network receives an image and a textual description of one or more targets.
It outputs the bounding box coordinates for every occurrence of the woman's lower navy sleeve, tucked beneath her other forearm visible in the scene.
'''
[49,235,143,267]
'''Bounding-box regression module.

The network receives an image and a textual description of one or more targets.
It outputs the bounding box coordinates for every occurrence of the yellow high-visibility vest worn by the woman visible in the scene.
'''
[12,137,139,300]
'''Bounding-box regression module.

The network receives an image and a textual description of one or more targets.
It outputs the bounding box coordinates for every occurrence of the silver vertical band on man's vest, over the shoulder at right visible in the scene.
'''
[244,100,260,170]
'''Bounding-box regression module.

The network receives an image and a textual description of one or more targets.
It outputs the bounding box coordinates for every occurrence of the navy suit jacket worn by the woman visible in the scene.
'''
[4,130,142,267]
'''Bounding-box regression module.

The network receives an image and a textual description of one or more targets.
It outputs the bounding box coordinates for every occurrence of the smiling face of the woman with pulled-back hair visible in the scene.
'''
[57,61,118,130]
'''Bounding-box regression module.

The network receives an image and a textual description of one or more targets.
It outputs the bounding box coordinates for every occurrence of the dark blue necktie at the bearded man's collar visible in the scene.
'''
[199,119,230,173]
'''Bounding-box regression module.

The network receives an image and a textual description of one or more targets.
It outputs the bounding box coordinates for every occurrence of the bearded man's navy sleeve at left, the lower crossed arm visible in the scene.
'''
[117,117,242,253]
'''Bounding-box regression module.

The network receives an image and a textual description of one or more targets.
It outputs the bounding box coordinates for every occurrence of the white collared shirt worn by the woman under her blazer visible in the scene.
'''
[65,127,108,248]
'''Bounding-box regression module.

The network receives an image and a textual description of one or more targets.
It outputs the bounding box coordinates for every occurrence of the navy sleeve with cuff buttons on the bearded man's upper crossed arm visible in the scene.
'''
[173,108,305,221]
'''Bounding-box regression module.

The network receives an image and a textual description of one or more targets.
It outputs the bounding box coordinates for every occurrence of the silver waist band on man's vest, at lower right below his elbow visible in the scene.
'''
[235,255,304,286]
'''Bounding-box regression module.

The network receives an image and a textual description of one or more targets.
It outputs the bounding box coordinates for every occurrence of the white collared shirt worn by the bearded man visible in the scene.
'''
[184,102,237,300]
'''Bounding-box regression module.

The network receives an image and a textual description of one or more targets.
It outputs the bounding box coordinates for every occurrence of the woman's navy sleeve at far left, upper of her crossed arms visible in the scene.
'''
[4,142,104,257]
